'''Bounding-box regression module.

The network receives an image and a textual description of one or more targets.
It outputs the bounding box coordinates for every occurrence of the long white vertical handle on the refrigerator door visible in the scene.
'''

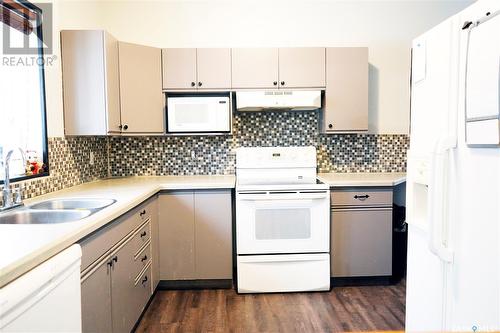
[428,137,457,263]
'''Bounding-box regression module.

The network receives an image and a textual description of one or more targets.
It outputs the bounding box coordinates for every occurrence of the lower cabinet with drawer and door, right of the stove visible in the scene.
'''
[330,188,392,278]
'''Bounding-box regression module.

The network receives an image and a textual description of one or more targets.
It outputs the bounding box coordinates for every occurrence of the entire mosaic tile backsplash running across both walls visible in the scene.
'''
[0,111,409,200]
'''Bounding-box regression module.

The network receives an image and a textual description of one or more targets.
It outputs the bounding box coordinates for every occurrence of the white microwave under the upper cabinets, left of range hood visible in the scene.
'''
[167,94,231,133]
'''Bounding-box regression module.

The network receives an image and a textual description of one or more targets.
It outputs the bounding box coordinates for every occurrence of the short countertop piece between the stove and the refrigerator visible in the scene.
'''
[318,172,406,187]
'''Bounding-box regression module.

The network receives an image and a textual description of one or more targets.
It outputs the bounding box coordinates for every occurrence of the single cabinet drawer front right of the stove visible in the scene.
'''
[331,187,392,206]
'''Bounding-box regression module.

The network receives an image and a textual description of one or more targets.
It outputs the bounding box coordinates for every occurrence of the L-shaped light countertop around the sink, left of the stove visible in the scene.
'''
[0,175,236,288]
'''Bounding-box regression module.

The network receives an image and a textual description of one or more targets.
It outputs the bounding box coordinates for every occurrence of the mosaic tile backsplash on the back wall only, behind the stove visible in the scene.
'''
[109,111,409,176]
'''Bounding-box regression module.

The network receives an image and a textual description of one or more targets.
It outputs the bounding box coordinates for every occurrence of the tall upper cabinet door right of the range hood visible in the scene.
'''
[323,47,368,132]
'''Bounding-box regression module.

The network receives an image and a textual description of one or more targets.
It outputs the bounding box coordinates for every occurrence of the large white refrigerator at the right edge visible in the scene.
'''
[406,1,500,332]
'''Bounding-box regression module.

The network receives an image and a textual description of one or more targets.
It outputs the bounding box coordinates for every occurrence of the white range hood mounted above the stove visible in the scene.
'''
[236,90,321,111]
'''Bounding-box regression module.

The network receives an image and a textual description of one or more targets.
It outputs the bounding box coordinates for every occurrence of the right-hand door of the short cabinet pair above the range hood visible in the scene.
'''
[279,47,326,88]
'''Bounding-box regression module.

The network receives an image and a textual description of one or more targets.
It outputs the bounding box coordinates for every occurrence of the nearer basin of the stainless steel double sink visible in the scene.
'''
[0,209,92,224]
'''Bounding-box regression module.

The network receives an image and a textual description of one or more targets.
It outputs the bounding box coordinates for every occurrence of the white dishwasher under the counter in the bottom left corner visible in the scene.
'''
[0,245,82,333]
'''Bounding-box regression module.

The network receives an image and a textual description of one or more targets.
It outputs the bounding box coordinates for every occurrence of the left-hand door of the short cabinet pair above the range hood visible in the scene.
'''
[231,48,278,89]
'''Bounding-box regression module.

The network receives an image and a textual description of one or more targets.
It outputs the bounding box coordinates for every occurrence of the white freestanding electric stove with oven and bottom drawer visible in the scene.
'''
[236,147,330,293]
